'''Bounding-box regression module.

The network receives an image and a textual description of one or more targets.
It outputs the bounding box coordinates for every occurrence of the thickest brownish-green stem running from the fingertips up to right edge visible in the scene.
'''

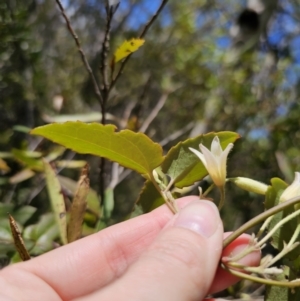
[223,196,300,248]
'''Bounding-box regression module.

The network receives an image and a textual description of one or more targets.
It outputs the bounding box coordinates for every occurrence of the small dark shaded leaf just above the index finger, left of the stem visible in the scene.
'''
[137,180,165,212]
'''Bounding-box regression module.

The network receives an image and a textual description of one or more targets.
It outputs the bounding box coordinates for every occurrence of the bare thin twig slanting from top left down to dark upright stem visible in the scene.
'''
[56,0,103,106]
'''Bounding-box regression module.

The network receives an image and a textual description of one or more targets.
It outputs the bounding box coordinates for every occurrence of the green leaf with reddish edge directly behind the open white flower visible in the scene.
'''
[162,132,240,188]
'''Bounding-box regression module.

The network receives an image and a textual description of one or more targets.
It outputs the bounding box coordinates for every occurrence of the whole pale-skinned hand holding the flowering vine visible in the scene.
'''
[0,196,260,301]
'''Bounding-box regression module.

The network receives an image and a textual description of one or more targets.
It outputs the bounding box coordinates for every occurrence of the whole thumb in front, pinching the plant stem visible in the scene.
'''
[86,200,223,301]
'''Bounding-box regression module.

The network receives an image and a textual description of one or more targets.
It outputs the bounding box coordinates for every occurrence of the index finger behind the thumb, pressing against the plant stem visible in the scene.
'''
[9,196,199,300]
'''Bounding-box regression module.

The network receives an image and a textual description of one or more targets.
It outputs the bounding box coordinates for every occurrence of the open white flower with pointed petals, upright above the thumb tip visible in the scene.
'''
[189,136,233,187]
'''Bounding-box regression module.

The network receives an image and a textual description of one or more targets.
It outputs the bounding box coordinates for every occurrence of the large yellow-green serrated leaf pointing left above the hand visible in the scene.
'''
[31,121,163,174]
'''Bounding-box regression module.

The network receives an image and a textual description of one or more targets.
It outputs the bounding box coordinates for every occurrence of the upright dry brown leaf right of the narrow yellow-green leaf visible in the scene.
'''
[67,165,90,243]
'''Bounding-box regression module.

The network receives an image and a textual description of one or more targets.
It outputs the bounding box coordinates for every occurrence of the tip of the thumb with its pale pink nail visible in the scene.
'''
[173,200,220,238]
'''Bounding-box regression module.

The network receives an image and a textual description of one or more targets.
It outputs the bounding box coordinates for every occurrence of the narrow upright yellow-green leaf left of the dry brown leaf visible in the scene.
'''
[44,161,68,244]
